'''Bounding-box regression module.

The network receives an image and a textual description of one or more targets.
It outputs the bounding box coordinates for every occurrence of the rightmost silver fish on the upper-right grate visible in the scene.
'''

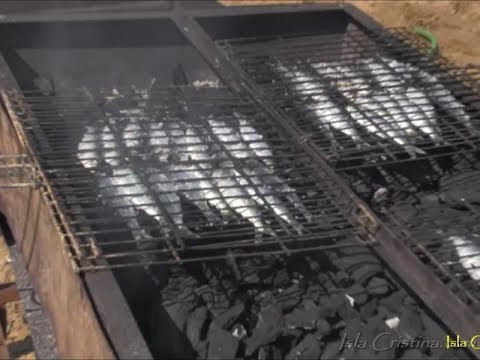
[388,59,480,135]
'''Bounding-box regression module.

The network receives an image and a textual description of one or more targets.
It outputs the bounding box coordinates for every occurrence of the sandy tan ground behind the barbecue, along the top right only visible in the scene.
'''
[221,0,480,65]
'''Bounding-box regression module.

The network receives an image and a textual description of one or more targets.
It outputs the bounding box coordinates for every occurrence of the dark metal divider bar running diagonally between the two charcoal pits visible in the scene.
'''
[172,4,480,359]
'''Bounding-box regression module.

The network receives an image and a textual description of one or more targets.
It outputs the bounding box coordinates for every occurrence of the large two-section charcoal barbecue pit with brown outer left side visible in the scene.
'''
[0,3,479,358]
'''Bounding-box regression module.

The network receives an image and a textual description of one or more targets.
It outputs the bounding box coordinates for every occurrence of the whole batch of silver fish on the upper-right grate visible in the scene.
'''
[276,57,479,158]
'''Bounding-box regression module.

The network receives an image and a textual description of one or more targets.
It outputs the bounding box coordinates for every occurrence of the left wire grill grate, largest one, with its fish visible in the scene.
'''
[2,86,376,270]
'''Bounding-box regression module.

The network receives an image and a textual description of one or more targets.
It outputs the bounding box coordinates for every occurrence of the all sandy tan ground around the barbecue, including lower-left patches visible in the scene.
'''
[0,0,480,359]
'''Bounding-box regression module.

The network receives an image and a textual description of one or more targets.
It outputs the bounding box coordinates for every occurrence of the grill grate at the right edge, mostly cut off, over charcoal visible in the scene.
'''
[389,200,480,307]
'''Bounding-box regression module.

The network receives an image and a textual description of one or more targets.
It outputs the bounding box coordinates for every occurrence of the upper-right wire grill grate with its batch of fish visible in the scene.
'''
[218,25,480,170]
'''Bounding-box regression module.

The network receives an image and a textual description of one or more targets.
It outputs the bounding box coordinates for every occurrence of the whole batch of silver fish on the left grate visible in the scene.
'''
[77,87,311,248]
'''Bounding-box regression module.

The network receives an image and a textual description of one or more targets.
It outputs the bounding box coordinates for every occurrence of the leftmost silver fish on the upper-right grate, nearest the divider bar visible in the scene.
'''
[277,66,362,144]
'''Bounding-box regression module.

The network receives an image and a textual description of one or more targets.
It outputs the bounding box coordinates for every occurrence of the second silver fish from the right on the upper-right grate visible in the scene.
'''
[362,59,441,143]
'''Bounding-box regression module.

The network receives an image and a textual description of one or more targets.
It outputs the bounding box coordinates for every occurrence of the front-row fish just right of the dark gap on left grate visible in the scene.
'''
[212,162,272,241]
